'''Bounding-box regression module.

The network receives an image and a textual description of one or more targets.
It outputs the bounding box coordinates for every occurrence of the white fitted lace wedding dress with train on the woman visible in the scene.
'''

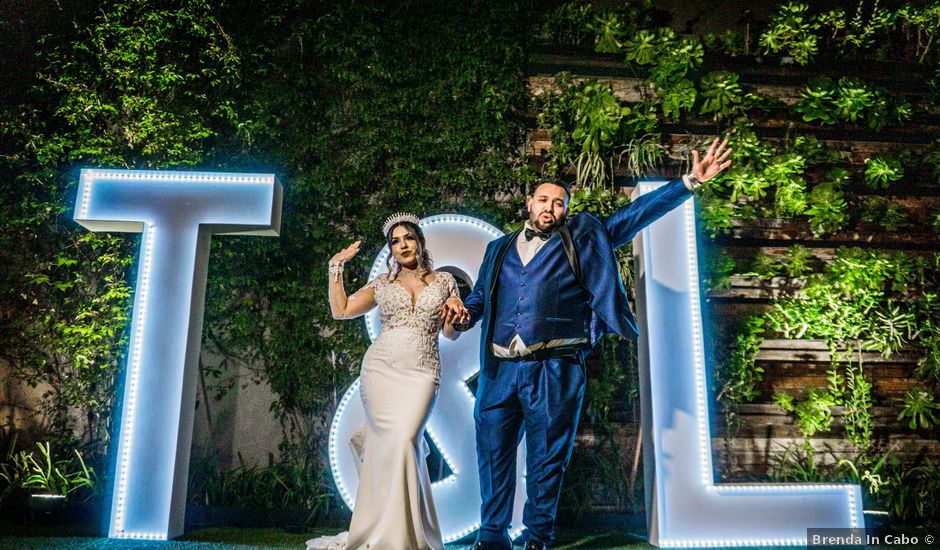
[307,271,457,550]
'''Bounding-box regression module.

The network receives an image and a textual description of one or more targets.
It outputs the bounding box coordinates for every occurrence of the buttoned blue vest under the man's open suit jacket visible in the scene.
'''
[493,234,592,346]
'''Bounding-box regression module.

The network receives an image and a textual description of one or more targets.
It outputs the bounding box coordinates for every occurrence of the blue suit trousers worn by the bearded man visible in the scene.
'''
[474,354,585,548]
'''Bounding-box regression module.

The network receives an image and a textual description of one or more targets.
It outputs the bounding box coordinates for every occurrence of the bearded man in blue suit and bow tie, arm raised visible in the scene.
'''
[445,138,731,550]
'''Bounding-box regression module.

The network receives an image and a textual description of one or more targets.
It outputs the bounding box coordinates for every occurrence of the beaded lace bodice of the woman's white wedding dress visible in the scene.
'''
[369,271,459,336]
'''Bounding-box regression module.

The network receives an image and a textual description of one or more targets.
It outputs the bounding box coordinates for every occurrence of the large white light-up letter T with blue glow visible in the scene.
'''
[75,169,281,539]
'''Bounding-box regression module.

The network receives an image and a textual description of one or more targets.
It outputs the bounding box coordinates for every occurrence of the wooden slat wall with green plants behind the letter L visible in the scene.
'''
[531,0,940,522]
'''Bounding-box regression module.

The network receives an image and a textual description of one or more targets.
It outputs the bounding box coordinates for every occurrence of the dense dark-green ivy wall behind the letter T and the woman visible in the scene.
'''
[0,0,533,486]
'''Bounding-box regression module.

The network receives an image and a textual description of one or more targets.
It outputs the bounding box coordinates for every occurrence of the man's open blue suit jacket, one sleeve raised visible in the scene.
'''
[465,179,692,371]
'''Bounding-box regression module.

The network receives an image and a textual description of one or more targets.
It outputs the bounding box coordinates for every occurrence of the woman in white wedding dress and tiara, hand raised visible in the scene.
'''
[307,214,466,550]
